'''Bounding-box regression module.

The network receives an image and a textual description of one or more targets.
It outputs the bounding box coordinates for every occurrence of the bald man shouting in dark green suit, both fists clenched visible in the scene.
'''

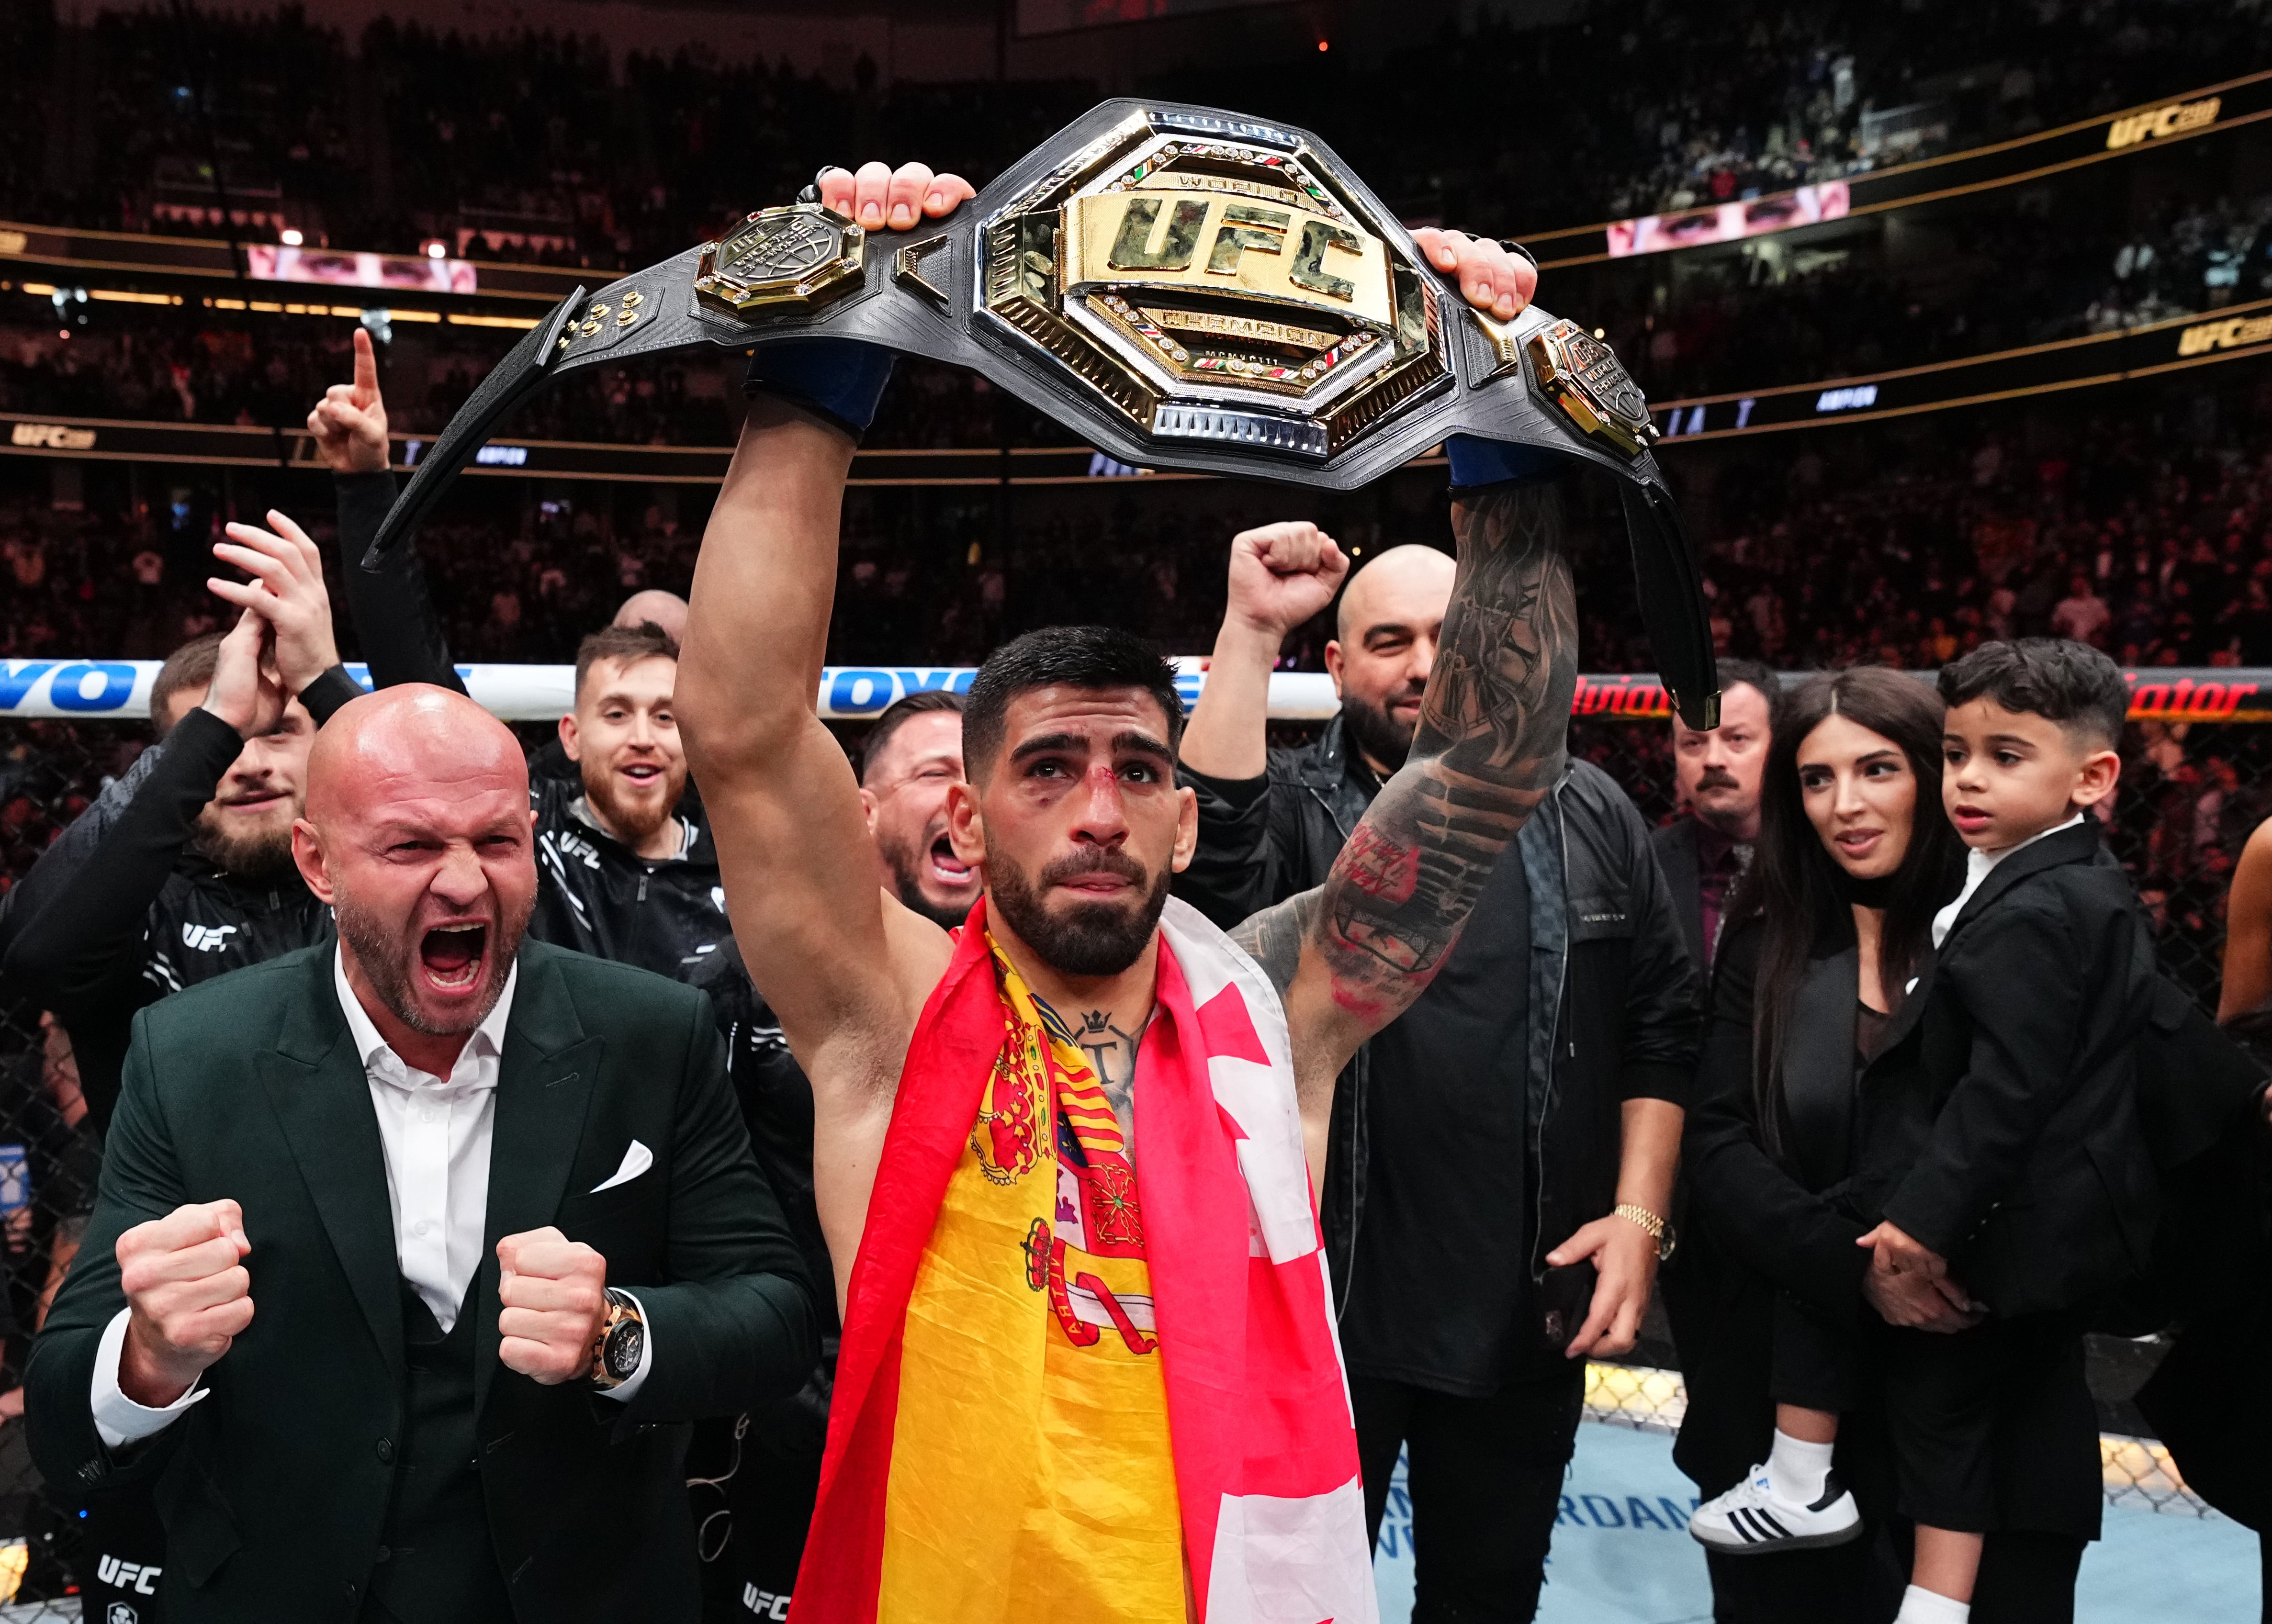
[27,683,818,1624]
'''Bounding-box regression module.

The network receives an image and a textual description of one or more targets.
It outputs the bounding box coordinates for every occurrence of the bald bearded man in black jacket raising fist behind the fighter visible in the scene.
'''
[1175,517,1697,1620]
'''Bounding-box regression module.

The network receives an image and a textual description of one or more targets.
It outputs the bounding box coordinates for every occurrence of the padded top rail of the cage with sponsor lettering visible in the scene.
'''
[0,654,2272,722]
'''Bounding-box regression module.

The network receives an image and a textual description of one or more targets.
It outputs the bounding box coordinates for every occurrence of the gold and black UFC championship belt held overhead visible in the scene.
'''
[363,100,1720,727]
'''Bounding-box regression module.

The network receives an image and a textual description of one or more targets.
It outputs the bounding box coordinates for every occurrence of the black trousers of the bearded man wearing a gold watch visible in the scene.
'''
[1350,1361,1586,1624]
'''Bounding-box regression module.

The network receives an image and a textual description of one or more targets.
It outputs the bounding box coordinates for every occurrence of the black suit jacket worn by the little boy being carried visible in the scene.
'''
[1865,822,2160,1315]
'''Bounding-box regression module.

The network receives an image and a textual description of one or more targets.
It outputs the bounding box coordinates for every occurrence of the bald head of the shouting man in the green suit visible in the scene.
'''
[293,683,536,1049]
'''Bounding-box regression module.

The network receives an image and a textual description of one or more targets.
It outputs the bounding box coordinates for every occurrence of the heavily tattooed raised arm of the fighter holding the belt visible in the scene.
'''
[1281,482,1577,1179]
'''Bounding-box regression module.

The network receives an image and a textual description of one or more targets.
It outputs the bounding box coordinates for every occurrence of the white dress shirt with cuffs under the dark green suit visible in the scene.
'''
[93,947,654,1449]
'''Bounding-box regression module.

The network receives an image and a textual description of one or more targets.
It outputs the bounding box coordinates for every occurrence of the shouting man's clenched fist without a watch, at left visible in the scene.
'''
[118,1201,252,1411]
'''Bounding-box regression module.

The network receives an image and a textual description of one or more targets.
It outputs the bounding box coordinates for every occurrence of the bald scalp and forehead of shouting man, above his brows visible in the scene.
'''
[307,682,529,822]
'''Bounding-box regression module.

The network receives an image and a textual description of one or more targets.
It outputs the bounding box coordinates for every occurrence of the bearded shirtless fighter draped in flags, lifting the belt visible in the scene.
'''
[679,164,1577,1624]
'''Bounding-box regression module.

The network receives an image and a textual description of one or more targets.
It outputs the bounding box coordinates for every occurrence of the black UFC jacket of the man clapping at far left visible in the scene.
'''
[0,690,359,1144]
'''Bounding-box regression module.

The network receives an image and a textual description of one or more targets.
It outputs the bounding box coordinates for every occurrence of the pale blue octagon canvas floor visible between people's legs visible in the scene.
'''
[1374,1422,2259,1624]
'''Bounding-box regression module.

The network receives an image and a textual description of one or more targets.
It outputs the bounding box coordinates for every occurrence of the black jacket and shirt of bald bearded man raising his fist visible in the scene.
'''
[1175,720,1699,1395]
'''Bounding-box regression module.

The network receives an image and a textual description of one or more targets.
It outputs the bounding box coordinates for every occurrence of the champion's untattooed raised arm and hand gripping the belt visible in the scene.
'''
[677,164,972,1283]
